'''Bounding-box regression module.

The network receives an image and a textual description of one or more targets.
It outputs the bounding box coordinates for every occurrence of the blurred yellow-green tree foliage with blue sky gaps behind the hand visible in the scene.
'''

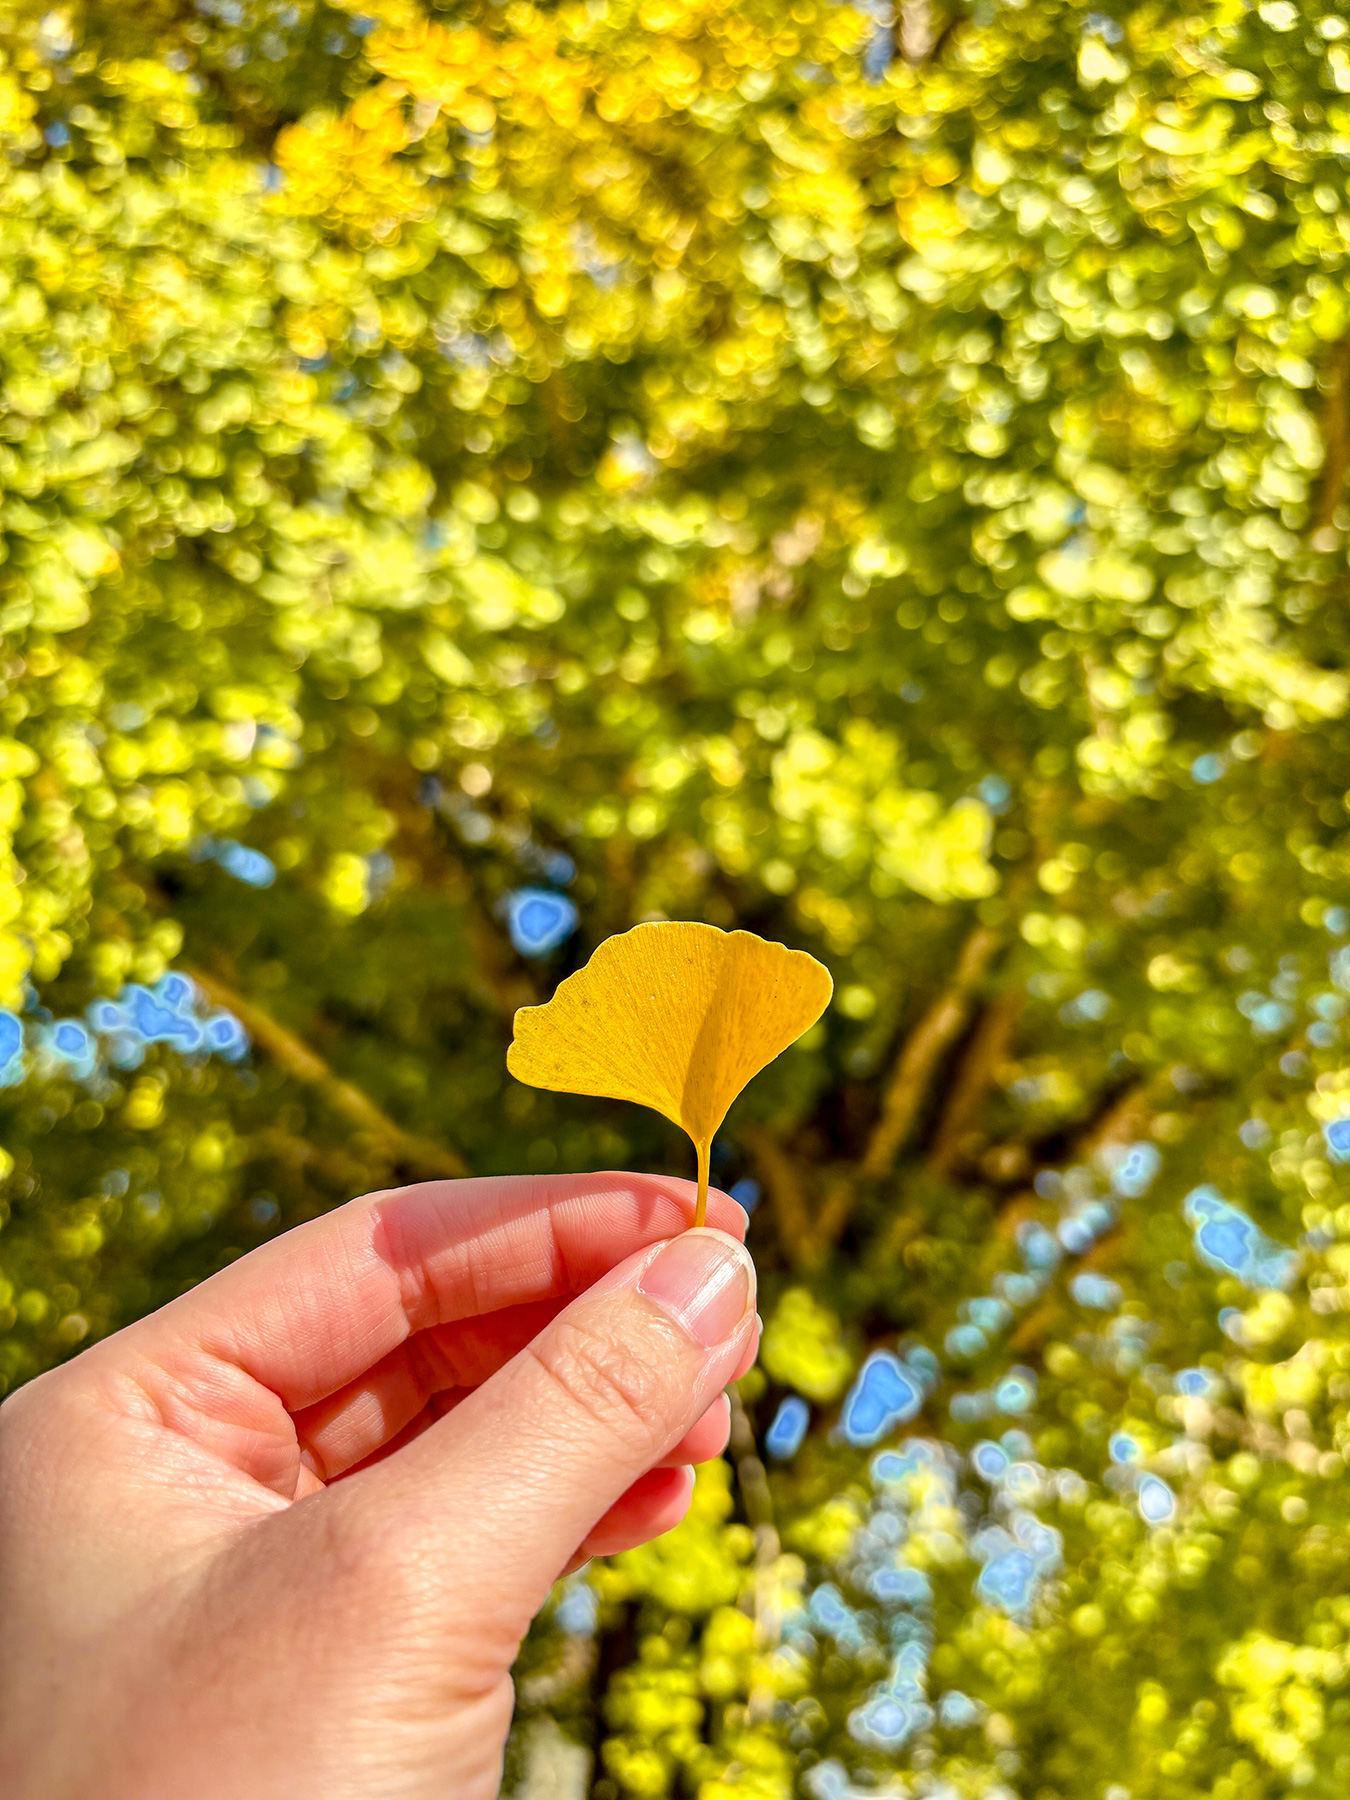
[13,0,1350,1800]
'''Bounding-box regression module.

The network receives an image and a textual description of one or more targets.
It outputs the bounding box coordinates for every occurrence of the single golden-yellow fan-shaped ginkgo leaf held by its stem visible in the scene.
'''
[506,923,833,1224]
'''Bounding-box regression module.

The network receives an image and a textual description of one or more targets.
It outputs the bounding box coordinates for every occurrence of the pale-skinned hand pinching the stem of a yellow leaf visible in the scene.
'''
[0,1174,758,1800]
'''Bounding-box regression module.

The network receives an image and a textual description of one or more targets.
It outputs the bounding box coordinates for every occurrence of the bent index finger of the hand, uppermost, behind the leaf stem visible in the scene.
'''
[104,1172,745,1411]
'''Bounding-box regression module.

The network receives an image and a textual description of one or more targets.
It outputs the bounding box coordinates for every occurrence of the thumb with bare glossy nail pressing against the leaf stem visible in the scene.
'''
[333,1229,754,1636]
